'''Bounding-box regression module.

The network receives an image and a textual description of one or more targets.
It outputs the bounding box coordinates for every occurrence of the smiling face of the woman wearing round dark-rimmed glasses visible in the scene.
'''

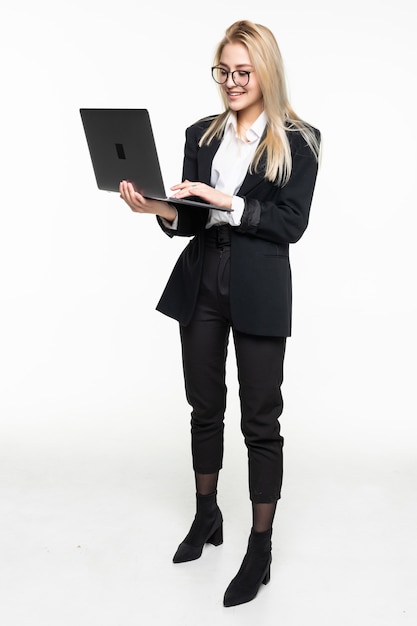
[219,43,263,123]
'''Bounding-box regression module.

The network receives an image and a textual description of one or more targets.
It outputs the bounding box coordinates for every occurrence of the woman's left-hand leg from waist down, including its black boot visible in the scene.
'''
[174,239,230,563]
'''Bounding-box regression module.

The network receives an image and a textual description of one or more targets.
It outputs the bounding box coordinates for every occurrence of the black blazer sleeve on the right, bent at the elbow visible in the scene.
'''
[236,129,320,244]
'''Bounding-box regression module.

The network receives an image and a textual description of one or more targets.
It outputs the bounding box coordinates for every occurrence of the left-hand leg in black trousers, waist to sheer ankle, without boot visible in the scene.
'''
[180,239,230,478]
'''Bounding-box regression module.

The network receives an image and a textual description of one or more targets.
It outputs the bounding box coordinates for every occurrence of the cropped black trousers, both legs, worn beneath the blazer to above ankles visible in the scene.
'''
[180,226,286,503]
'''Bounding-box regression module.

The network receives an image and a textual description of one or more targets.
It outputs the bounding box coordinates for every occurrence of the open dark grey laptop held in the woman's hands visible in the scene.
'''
[80,108,228,211]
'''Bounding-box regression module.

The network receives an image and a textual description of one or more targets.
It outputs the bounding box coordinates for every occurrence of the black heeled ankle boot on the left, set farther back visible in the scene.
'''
[173,492,223,563]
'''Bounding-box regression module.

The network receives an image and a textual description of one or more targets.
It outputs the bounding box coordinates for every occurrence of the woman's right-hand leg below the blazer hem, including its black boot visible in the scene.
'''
[224,332,285,606]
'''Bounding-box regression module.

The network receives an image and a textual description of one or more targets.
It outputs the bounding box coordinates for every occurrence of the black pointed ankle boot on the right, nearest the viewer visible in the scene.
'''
[223,530,272,606]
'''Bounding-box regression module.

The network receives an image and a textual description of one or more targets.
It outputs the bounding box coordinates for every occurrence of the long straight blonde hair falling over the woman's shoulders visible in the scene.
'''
[200,20,320,185]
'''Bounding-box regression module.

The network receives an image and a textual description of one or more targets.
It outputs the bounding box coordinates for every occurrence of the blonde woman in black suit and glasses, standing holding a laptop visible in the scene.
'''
[120,21,320,606]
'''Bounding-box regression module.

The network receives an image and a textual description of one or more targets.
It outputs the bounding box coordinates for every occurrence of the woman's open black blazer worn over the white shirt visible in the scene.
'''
[156,118,320,337]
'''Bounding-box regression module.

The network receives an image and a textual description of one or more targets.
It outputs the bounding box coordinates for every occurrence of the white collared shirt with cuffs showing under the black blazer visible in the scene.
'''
[163,112,266,230]
